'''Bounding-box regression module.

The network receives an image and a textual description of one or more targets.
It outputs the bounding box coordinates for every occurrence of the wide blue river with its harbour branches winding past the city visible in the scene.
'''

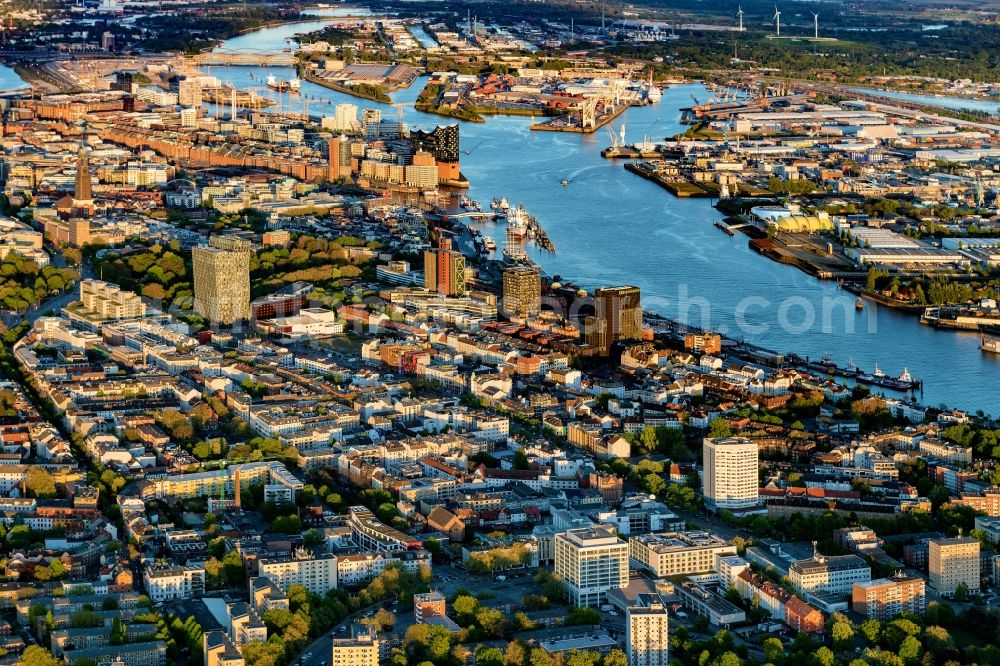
[201,21,1000,414]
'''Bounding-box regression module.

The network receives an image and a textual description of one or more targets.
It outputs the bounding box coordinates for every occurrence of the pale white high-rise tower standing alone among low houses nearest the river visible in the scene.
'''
[702,437,760,510]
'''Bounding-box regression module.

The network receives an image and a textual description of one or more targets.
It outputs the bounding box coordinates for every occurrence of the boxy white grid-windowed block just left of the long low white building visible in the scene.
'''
[555,525,628,606]
